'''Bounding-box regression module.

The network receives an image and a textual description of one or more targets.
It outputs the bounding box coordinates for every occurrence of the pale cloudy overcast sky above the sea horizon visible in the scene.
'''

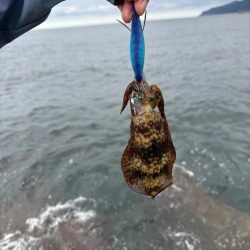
[38,0,232,28]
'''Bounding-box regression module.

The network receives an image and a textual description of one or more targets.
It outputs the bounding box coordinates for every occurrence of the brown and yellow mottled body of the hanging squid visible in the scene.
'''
[121,81,176,198]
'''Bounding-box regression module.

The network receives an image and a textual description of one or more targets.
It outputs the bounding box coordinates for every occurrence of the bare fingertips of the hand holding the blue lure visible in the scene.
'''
[118,0,149,23]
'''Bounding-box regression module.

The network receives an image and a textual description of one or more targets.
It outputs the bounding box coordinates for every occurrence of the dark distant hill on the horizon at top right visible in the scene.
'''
[201,0,250,16]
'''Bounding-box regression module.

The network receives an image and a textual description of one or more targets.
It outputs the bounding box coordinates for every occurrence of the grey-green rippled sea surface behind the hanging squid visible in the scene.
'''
[0,14,250,250]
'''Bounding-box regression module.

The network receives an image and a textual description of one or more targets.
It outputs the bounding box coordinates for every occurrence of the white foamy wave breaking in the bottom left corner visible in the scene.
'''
[0,197,102,250]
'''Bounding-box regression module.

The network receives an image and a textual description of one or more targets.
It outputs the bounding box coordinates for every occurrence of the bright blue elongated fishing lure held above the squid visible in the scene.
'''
[130,7,145,82]
